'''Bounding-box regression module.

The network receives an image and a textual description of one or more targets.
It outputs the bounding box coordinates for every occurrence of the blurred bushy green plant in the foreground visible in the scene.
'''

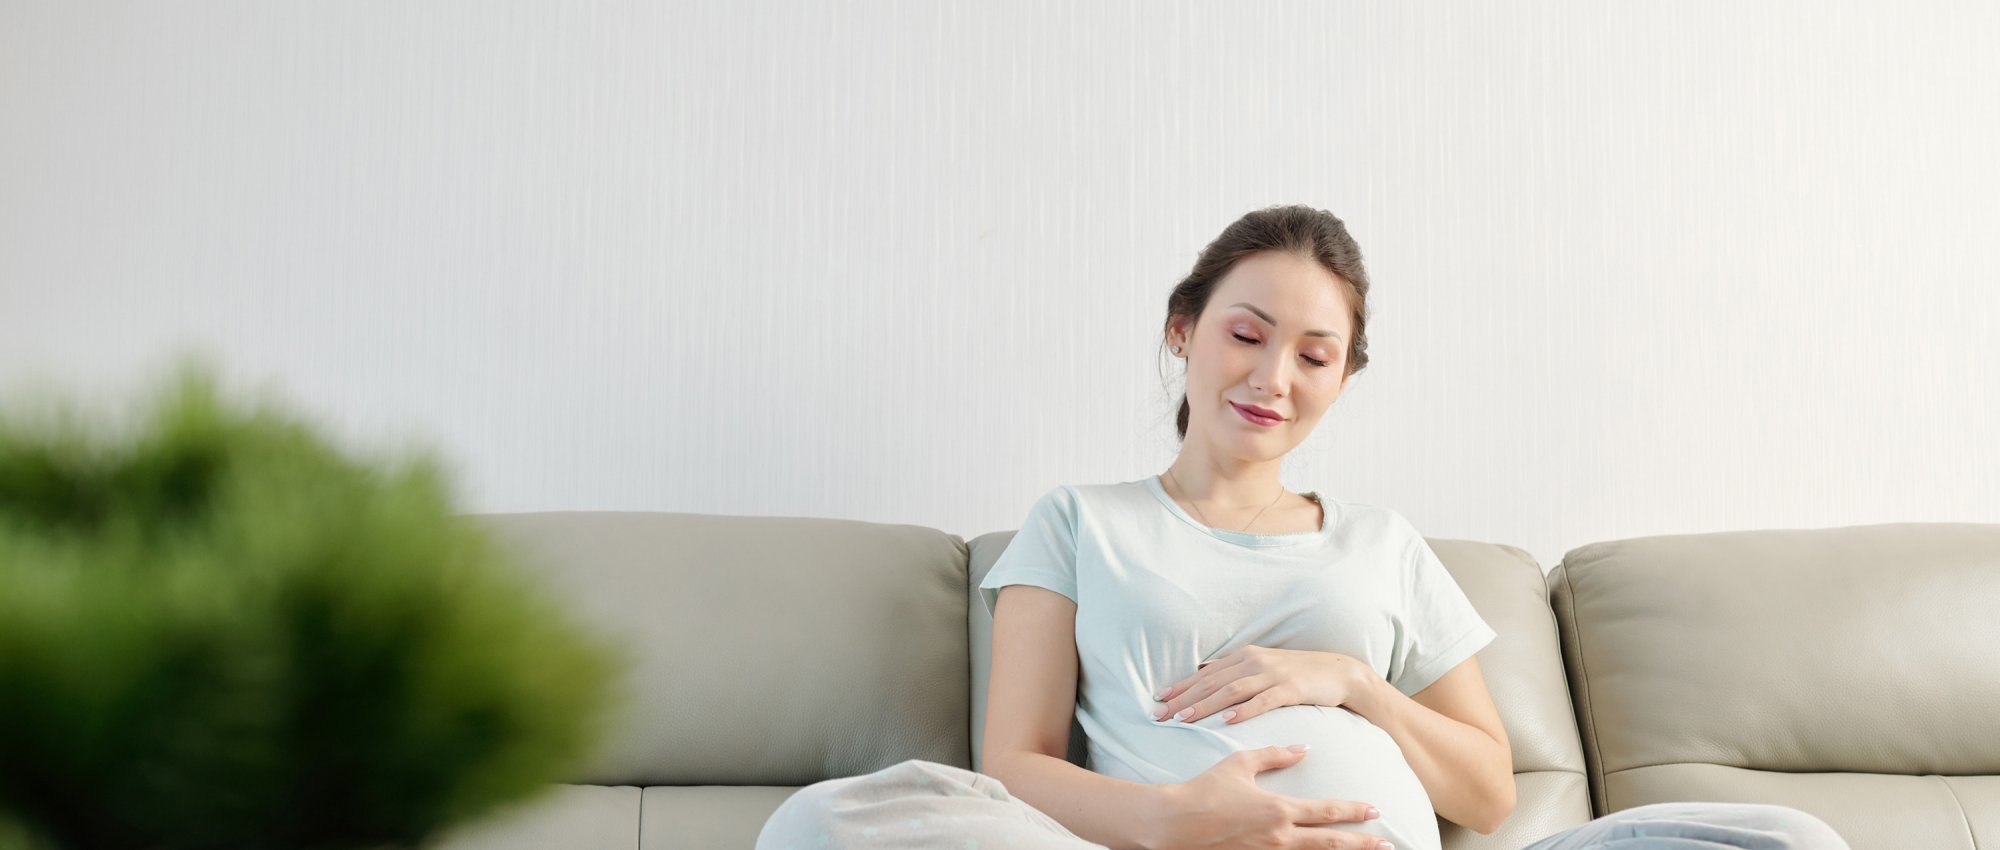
[0,362,624,850]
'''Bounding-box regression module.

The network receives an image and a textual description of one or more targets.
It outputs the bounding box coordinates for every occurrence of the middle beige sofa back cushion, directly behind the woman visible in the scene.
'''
[966,530,1590,850]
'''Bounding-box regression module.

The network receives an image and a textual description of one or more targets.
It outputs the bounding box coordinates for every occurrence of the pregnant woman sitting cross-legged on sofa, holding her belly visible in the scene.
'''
[756,206,1846,850]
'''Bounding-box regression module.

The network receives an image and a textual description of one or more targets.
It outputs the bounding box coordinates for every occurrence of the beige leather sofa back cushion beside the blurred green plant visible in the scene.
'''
[474,512,972,786]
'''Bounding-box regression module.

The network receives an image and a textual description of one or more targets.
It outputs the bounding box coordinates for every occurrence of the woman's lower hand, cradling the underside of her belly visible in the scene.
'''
[1148,746,1386,850]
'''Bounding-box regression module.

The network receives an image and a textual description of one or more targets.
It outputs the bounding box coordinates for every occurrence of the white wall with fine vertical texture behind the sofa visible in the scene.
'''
[0,0,2000,568]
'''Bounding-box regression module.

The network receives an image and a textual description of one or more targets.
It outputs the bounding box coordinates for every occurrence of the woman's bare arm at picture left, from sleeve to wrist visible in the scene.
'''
[980,584,1166,850]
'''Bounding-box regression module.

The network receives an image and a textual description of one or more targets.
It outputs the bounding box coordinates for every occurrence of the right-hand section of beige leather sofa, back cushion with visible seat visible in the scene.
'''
[1550,524,2000,848]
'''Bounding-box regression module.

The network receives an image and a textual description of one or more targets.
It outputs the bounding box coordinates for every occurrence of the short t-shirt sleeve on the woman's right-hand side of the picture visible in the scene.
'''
[1386,528,1498,696]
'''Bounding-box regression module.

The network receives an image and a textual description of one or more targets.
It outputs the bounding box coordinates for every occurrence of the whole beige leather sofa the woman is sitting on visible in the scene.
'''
[436,512,2000,850]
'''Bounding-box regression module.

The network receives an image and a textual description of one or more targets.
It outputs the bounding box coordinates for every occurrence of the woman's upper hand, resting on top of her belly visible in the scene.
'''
[1152,646,1380,724]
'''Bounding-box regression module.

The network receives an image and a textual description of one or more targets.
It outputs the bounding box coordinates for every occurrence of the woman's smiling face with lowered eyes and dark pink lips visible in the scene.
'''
[1168,250,1354,460]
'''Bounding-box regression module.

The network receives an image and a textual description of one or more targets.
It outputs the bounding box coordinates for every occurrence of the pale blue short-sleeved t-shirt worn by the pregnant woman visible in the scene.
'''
[980,476,1496,850]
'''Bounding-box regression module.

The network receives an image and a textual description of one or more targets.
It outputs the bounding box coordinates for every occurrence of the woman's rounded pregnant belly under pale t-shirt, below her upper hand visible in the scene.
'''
[1086,706,1440,850]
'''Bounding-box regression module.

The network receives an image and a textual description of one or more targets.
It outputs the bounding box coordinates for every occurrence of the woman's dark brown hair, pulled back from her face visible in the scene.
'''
[1160,204,1368,440]
